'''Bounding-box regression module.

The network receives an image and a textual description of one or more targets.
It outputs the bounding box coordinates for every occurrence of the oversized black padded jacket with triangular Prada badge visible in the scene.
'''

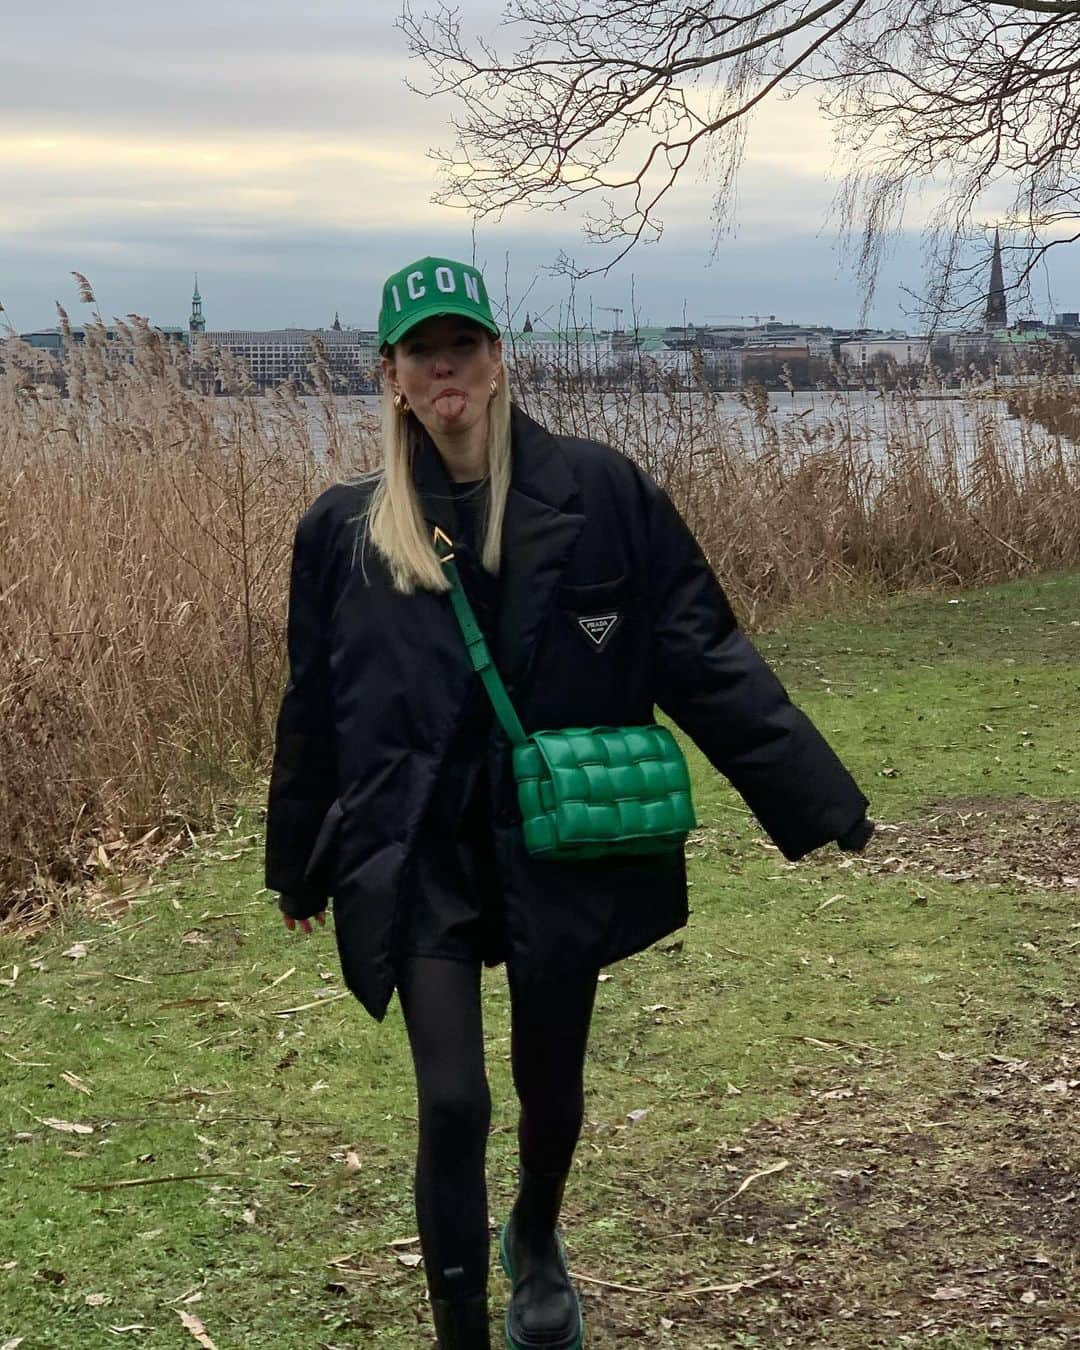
[266,409,867,1021]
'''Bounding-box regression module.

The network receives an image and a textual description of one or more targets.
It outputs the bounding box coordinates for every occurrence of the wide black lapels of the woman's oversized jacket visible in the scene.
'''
[413,408,585,694]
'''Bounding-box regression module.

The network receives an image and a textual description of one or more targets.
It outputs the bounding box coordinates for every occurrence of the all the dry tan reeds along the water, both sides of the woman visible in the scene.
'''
[0,301,1080,921]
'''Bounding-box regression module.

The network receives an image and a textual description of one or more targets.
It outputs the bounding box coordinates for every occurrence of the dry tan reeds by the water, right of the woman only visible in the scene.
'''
[518,374,1080,628]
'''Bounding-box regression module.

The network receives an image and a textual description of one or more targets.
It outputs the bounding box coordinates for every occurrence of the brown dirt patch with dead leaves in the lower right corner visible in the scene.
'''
[589,1002,1080,1350]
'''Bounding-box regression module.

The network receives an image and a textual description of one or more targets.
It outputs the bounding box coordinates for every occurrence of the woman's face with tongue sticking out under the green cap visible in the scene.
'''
[382,315,502,436]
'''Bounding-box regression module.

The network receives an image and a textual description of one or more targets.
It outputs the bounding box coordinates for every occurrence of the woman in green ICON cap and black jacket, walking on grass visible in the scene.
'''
[266,258,872,1350]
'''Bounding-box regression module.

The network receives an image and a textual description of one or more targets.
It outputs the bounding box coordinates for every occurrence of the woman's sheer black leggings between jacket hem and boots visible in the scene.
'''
[398,956,598,1299]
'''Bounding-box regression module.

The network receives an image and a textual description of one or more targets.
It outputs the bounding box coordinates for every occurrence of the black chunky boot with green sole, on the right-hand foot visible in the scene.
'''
[498,1166,585,1350]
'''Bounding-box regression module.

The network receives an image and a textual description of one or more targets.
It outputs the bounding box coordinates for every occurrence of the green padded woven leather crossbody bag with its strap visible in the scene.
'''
[433,527,698,861]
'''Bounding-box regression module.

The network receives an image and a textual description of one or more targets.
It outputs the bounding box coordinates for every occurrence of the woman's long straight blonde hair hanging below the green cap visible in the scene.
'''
[354,367,512,595]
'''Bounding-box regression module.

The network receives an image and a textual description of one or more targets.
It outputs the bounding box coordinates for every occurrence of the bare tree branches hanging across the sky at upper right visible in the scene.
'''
[400,0,1080,317]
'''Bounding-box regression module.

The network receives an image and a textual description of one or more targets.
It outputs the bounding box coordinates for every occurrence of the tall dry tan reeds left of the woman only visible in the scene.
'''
[0,301,380,918]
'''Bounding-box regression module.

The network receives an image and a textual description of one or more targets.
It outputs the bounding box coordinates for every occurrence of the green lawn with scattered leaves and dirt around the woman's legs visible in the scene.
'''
[0,574,1080,1350]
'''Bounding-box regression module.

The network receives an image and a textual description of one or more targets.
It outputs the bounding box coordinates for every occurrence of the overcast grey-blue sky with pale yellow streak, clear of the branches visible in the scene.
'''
[0,0,1080,331]
